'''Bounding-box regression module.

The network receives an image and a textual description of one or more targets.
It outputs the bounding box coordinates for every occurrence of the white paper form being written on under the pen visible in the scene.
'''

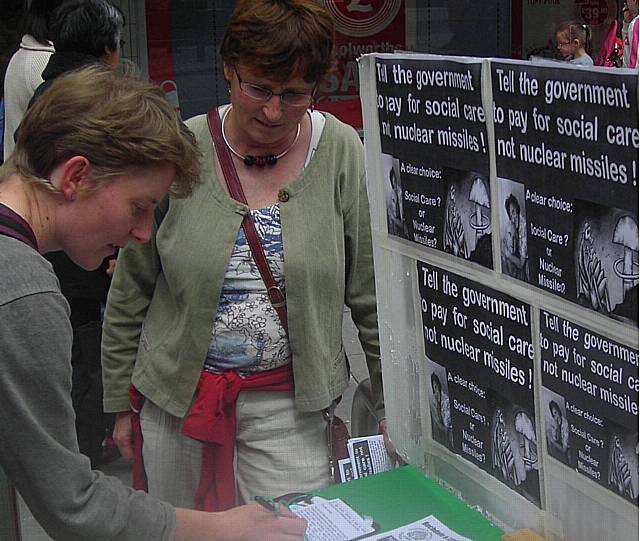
[293,499,375,541]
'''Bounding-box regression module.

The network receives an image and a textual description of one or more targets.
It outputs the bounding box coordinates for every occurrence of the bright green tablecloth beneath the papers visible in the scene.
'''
[317,466,503,541]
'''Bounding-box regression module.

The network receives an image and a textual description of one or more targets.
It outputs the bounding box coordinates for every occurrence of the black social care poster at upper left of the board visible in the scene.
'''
[376,57,493,268]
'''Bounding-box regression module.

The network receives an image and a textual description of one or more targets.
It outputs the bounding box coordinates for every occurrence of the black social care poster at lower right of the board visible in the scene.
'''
[540,310,639,505]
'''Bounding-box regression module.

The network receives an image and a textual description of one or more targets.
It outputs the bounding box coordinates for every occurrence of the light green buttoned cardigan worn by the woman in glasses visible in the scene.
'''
[102,115,384,418]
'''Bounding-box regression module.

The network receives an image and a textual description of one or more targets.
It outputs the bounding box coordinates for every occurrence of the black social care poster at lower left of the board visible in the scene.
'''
[417,261,540,507]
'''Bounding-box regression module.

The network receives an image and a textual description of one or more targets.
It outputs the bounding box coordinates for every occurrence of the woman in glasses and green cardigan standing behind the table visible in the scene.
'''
[103,0,386,509]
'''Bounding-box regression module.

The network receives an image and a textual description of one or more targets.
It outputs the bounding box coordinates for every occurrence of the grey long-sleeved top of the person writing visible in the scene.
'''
[0,235,175,541]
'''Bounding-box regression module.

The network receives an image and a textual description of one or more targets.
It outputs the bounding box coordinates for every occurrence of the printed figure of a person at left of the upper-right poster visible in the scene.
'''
[501,194,529,281]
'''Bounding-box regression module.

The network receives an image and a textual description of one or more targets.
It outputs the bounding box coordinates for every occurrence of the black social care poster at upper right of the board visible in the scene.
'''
[492,61,639,325]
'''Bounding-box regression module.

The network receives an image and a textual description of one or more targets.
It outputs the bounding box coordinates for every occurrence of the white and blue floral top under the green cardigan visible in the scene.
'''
[205,205,291,374]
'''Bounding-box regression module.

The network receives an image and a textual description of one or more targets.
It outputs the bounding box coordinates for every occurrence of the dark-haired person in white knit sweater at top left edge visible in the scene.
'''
[4,0,62,160]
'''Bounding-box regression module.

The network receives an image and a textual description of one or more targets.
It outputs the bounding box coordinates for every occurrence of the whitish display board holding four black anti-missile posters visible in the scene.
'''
[360,54,639,541]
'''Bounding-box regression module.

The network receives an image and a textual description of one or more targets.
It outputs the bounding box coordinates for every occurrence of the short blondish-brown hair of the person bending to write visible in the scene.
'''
[0,65,201,197]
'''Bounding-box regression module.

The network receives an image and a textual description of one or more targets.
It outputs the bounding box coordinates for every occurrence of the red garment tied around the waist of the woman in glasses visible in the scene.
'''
[129,364,294,511]
